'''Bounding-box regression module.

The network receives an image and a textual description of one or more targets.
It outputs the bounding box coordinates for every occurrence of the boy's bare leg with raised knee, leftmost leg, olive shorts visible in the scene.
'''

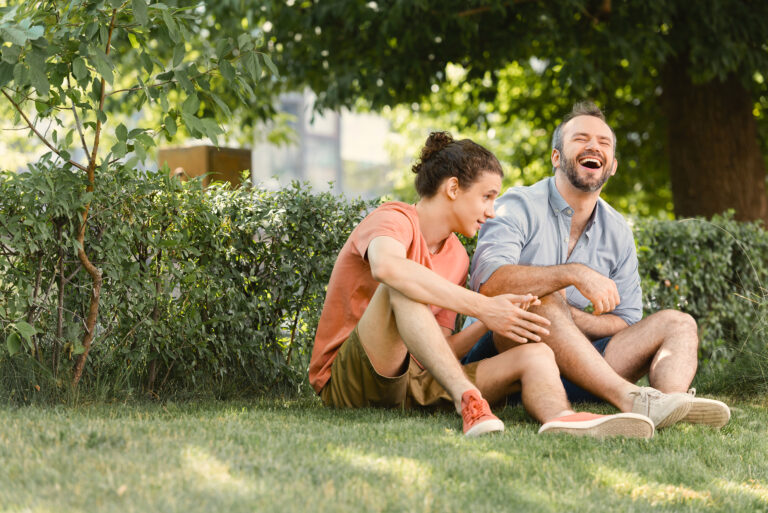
[358,284,476,412]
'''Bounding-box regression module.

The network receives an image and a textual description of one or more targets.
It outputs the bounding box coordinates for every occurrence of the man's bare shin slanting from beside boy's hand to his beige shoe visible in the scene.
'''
[494,292,637,411]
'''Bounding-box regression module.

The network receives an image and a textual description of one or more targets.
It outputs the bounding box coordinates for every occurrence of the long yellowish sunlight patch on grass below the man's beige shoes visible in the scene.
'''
[594,465,712,506]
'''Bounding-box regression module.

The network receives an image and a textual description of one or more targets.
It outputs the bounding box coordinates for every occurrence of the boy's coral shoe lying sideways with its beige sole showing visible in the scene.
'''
[539,412,653,438]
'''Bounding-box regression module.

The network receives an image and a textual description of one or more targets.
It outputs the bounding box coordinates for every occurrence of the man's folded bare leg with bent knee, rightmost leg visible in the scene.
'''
[605,310,699,393]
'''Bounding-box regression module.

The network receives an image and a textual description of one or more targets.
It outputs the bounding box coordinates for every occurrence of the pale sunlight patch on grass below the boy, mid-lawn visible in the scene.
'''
[332,448,432,490]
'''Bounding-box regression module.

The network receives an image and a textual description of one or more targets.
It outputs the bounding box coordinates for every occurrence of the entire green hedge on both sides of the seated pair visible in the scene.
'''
[0,161,768,402]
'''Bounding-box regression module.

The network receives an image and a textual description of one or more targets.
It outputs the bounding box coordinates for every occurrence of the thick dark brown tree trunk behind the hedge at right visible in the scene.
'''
[662,59,768,223]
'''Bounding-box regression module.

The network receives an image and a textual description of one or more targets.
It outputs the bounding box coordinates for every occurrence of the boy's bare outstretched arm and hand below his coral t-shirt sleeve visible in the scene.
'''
[366,236,550,342]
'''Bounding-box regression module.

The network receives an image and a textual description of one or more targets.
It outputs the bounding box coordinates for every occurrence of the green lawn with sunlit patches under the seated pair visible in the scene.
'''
[0,398,768,513]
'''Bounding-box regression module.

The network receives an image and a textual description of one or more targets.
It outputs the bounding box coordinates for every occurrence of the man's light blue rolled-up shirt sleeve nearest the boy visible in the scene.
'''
[469,193,530,291]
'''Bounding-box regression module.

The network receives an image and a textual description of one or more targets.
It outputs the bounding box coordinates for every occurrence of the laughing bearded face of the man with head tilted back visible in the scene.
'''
[553,116,616,192]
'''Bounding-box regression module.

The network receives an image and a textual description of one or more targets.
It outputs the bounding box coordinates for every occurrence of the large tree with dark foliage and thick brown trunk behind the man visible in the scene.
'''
[263,0,768,220]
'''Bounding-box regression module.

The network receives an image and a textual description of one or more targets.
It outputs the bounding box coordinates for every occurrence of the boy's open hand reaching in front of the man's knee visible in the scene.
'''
[477,294,550,343]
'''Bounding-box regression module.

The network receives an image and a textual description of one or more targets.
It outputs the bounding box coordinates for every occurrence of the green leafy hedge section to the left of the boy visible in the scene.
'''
[0,161,371,401]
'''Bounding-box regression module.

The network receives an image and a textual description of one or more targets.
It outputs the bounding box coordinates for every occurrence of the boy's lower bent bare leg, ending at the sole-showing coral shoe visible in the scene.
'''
[476,342,573,423]
